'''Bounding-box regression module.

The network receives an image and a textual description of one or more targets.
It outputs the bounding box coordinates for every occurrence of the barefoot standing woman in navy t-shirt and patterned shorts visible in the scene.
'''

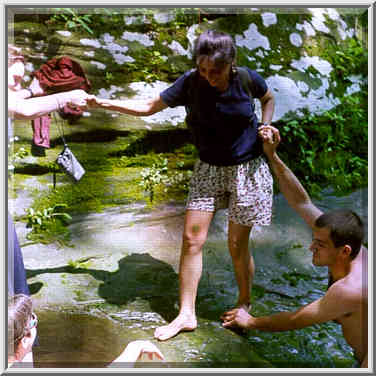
[88,30,274,340]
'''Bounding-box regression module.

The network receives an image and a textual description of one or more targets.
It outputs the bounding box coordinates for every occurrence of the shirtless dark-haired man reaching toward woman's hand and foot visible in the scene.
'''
[221,126,368,368]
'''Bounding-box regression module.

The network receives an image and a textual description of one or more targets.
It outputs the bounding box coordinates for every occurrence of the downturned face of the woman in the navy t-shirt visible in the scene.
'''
[198,57,231,91]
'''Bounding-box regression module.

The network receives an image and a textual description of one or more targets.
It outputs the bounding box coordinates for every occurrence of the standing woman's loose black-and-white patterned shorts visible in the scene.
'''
[186,156,273,226]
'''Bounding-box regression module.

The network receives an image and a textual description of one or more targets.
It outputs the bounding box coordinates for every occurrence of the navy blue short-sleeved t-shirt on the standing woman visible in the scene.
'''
[160,68,268,166]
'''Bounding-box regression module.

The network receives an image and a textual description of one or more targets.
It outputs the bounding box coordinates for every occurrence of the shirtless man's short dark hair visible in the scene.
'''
[315,209,364,259]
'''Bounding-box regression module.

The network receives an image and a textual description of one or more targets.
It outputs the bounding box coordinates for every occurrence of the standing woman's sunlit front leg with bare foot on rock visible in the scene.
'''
[154,210,214,341]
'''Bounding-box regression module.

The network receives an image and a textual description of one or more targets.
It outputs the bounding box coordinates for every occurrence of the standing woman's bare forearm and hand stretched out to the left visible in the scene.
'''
[87,95,167,116]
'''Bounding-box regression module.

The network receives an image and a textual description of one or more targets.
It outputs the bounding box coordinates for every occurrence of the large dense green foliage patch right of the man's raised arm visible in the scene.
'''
[279,90,368,198]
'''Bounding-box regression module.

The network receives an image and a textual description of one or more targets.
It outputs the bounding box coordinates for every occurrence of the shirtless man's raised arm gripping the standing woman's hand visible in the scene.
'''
[259,126,322,228]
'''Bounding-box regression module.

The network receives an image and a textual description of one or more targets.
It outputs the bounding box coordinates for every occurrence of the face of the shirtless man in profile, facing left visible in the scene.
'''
[309,227,342,266]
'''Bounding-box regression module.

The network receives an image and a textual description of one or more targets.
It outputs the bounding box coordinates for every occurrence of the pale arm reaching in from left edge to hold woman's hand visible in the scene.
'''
[8,90,89,120]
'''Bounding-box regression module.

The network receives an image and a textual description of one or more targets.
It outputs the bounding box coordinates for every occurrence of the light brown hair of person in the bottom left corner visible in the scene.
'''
[8,294,33,356]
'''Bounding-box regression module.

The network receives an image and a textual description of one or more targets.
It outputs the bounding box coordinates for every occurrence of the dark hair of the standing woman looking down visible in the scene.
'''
[193,30,236,66]
